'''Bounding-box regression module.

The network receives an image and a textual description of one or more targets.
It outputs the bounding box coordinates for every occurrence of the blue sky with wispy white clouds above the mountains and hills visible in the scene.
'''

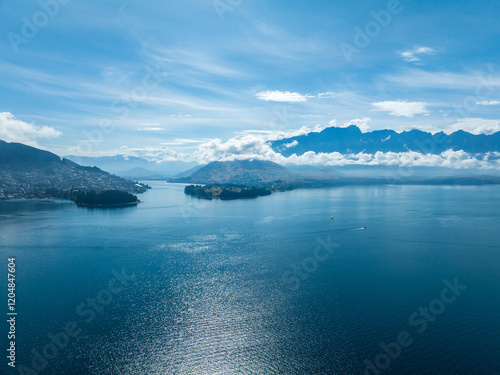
[0,0,500,166]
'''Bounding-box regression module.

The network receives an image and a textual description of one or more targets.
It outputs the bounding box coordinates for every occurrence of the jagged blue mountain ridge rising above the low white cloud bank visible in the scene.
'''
[271,125,500,157]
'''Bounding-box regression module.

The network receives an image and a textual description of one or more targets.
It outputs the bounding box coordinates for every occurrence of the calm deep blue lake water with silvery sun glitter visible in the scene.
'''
[0,182,500,375]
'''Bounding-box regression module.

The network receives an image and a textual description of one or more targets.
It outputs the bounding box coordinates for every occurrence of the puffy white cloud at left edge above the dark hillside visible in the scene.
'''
[0,112,62,147]
